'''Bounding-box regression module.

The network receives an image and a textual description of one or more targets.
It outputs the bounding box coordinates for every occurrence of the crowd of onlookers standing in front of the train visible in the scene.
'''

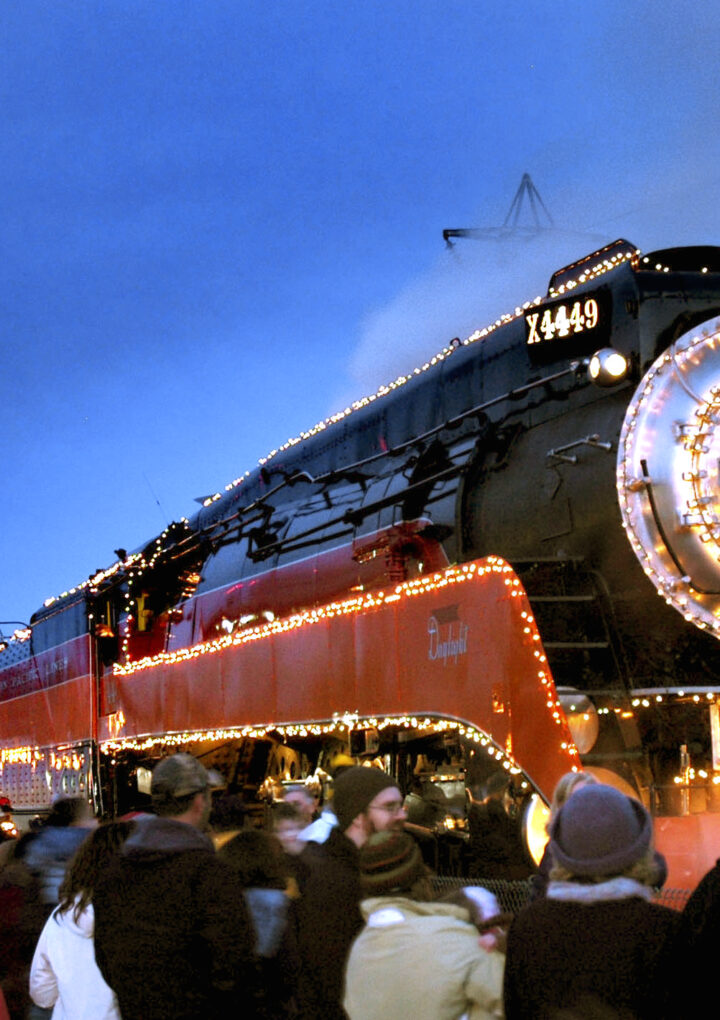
[0,754,720,1020]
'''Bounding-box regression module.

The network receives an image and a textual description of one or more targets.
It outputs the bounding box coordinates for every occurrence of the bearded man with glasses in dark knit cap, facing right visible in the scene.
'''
[291,765,405,1020]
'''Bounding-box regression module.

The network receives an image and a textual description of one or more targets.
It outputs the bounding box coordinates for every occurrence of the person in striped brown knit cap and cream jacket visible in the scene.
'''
[345,829,504,1020]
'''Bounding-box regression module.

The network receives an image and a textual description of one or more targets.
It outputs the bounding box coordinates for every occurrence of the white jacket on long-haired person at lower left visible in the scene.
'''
[30,904,120,1020]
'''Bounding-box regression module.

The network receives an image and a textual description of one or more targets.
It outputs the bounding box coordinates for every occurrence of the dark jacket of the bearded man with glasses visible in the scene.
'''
[297,828,362,1020]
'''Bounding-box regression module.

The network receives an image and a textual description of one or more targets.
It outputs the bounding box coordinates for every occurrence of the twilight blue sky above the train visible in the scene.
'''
[0,0,720,620]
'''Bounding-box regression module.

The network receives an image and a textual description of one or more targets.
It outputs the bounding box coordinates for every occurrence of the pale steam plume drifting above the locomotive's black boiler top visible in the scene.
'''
[342,158,720,397]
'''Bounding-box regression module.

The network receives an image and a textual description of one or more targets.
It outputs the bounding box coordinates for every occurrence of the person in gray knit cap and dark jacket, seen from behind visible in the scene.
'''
[505,783,678,1020]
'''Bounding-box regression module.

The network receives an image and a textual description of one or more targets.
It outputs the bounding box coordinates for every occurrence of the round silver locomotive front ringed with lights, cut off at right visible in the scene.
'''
[617,319,720,638]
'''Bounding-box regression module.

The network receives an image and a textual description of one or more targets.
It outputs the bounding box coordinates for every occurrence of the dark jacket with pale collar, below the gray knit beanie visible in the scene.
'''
[505,878,679,1020]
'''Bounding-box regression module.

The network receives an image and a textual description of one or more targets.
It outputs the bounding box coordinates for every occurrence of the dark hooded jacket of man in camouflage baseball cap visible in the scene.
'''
[93,817,257,1020]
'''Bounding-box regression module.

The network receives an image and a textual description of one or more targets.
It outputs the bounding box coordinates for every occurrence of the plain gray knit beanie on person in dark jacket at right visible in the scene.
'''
[550,783,653,878]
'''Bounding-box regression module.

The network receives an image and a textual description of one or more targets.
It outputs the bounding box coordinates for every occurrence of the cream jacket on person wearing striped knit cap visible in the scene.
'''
[345,897,505,1020]
